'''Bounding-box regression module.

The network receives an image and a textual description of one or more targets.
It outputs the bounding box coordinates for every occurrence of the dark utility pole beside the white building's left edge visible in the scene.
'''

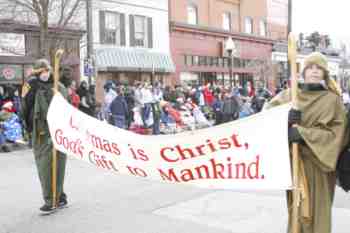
[86,0,94,87]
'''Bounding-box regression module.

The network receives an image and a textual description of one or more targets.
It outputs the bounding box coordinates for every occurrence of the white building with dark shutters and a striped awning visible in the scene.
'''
[93,0,175,102]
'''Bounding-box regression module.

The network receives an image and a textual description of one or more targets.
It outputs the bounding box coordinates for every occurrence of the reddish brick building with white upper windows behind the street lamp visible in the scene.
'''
[169,0,287,90]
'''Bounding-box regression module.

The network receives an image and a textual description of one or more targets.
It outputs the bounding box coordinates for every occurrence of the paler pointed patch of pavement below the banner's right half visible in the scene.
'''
[154,190,350,233]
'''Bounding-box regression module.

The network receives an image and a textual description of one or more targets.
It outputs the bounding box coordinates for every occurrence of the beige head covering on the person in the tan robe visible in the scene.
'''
[303,52,341,96]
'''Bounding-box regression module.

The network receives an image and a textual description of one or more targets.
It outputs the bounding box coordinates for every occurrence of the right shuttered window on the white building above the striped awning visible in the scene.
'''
[129,15,153,48]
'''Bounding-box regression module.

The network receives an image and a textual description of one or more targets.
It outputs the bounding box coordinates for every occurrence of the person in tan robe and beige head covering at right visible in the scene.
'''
[265,52,347,233]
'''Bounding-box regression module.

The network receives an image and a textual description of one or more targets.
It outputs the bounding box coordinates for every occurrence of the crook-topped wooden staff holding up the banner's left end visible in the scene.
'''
[51,49,63,208]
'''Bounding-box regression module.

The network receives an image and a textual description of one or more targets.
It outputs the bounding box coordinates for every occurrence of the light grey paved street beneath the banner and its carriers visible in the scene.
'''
[0,150,350,233]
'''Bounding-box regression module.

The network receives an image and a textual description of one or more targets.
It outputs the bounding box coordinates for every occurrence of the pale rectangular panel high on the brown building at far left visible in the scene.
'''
[0,33,25,56]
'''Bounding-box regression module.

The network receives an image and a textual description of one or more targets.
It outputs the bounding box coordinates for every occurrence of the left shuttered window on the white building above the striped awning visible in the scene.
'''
[100,11,125,45]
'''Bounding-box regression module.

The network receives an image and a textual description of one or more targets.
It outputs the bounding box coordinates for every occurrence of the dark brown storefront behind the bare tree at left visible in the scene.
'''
[0,20,84,86]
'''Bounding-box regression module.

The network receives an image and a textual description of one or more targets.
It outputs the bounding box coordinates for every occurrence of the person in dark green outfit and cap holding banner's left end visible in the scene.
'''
[22,59,68,212]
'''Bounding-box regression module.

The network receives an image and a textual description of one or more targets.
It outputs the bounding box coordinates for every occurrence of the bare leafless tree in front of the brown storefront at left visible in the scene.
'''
[0,0,85,57]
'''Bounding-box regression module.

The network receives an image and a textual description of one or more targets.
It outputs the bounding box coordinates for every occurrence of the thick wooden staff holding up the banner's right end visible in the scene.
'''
[288,33,300,233]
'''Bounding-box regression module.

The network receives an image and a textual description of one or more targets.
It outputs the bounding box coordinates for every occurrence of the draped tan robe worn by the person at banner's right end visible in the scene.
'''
[266,86,348,233]
